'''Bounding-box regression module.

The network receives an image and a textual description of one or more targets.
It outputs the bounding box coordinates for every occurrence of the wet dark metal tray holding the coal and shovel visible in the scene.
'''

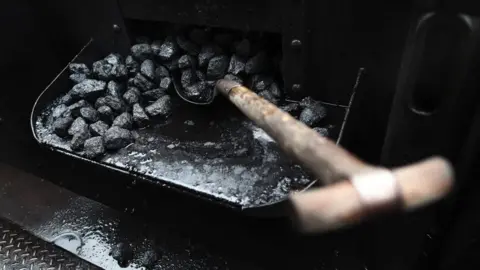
[31,40,360,216]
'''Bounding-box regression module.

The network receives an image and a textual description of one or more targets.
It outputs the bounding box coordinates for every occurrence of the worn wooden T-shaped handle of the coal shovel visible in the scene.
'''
[216,80,454,232]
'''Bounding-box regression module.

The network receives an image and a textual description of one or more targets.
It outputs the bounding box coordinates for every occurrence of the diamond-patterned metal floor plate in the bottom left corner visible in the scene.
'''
[0,219,100,270]
